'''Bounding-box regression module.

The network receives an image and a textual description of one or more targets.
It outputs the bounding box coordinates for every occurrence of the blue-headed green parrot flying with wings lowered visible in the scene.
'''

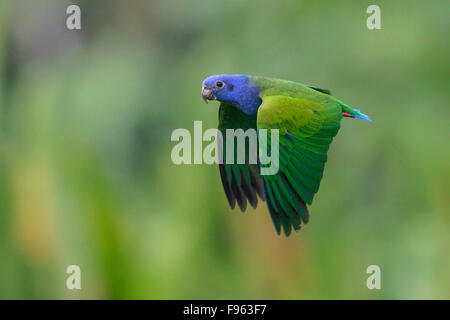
[202,74,372,237]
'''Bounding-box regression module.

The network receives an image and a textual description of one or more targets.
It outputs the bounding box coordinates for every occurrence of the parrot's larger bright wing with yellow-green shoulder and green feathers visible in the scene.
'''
[257,96,342,235]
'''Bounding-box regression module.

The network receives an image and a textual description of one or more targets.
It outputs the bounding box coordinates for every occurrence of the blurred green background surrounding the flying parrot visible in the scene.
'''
[0,0,450,299]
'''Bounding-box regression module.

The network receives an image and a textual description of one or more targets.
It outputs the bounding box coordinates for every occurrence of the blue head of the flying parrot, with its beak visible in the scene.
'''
[202,74,261,114]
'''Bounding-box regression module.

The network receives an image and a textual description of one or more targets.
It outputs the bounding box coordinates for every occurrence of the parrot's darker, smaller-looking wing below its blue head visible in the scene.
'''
[217,103,264,211]
